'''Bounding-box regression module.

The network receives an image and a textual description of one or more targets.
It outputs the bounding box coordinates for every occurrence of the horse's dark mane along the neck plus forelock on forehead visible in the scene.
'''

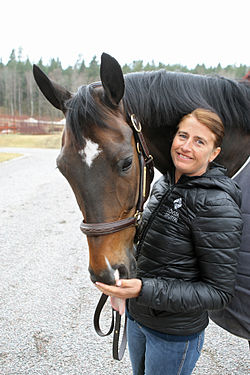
[66,70,250,145]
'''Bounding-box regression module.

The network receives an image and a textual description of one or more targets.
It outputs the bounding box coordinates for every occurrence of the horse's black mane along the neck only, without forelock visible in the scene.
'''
[123,70,250,132]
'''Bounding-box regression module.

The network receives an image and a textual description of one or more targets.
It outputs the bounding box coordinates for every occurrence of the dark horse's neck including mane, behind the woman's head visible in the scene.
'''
[124,71,250,176]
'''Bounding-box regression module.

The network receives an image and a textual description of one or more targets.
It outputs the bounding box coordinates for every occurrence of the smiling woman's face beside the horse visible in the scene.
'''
[171,117,221,182]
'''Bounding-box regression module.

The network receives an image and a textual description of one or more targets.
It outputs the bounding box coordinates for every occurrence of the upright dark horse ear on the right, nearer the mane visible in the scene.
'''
[100,53,124,105]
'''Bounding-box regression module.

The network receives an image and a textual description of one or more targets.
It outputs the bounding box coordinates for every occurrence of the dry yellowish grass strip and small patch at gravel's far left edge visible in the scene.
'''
[0,134,61,162]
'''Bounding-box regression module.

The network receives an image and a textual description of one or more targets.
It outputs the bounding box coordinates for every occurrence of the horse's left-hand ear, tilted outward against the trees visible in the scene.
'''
[33,65,72,113]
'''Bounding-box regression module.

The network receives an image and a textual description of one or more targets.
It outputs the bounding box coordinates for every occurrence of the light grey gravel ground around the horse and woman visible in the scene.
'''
[0,148,250,375]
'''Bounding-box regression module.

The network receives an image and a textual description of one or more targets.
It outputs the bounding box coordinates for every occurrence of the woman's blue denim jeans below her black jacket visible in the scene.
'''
[127,319,204,375]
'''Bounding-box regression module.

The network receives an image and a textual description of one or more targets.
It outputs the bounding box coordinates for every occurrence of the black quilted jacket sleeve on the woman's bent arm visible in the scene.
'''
[137,198,242,313]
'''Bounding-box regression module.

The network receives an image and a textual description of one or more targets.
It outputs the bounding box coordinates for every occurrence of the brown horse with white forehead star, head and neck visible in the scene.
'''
[33,53,250,344]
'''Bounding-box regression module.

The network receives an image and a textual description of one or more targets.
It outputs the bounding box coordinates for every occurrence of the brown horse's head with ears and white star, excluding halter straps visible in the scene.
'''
[33,54,149,284]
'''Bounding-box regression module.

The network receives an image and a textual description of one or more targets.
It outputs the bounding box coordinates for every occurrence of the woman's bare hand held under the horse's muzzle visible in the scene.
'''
[95,279,142,299]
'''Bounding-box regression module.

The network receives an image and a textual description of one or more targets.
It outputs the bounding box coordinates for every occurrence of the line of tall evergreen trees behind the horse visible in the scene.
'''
[0,48,250,120]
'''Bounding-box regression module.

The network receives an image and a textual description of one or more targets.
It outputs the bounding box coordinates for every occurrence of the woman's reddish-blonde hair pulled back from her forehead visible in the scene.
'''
[178,108,225,148]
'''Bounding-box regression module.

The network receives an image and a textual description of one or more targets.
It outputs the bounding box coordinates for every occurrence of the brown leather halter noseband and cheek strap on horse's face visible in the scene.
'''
[80,114,154,236]
